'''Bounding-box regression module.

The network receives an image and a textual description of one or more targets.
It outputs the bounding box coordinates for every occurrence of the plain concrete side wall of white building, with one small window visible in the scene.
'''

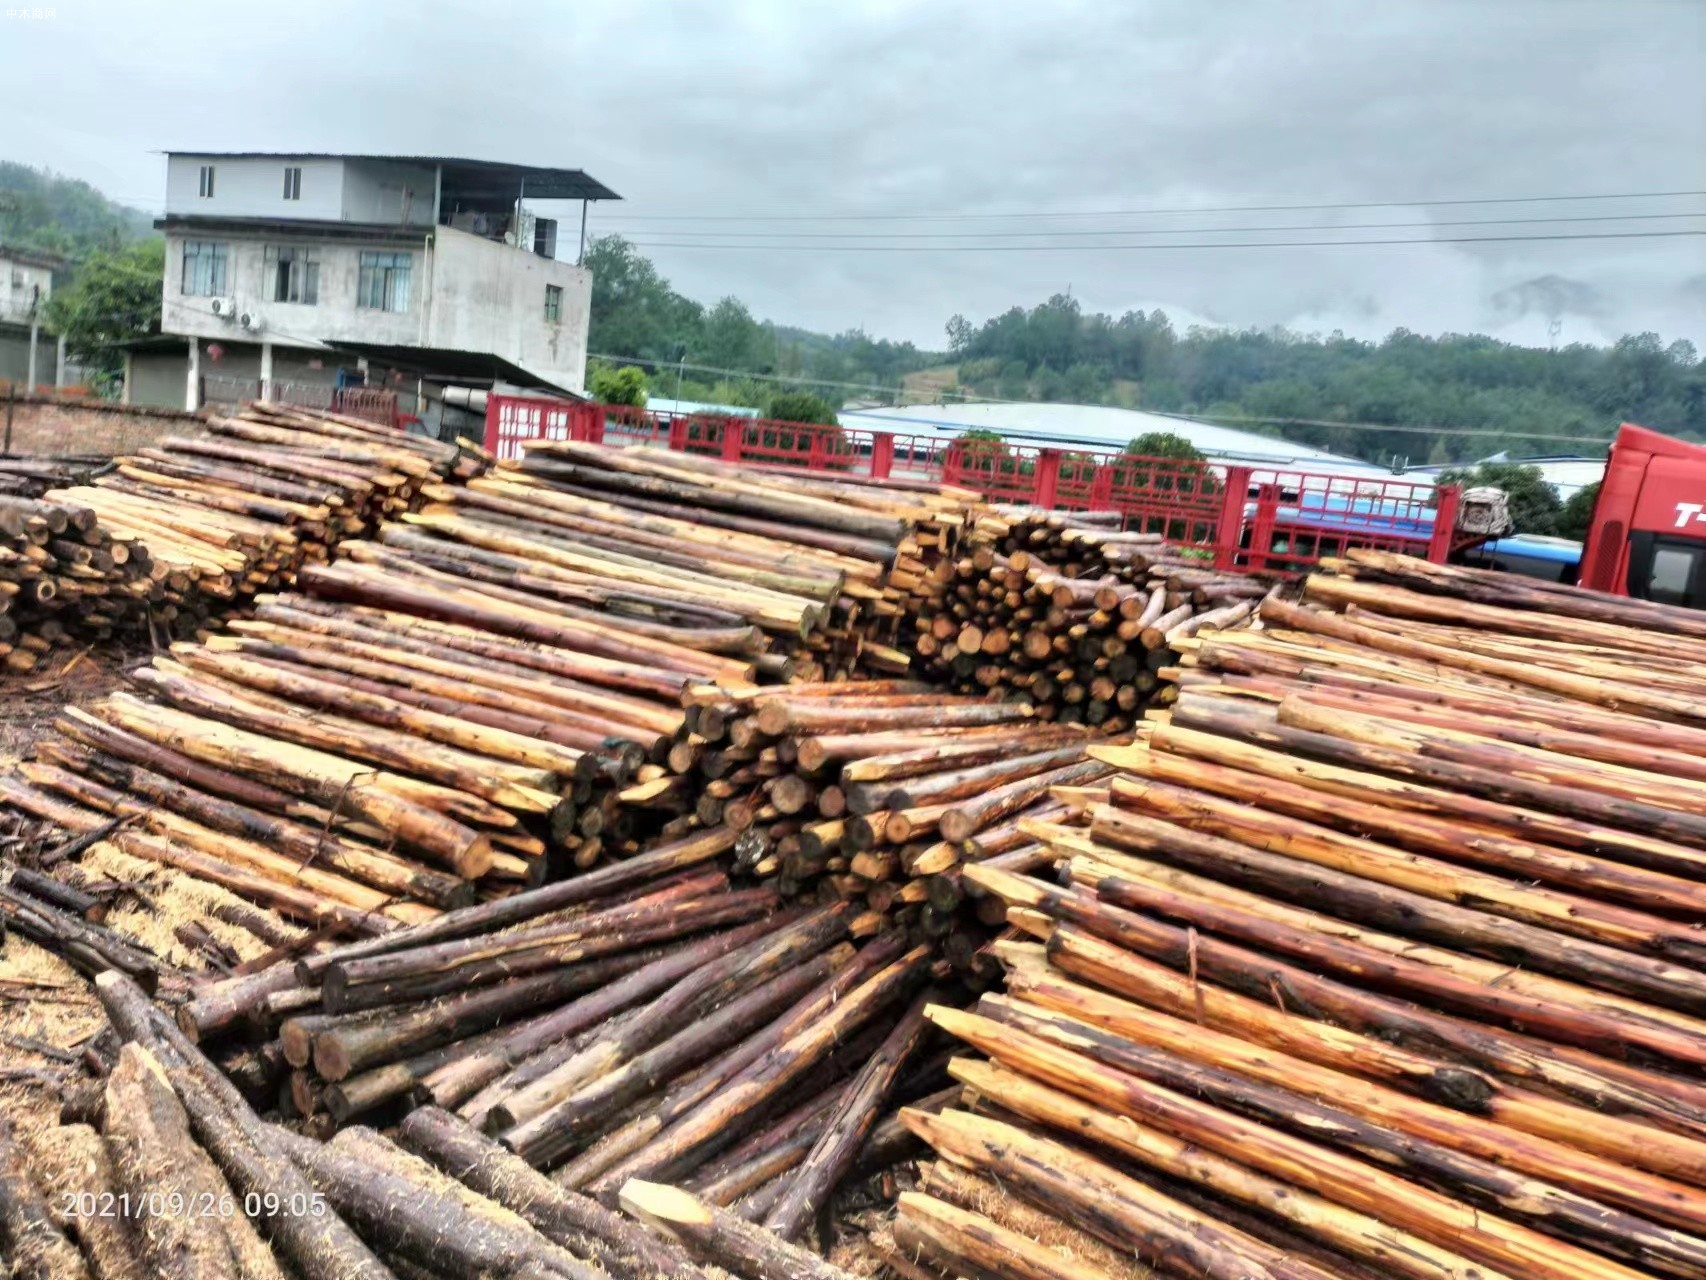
[427,227,592,391]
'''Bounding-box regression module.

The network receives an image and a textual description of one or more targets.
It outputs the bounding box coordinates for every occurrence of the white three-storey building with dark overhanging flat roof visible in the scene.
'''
[126,152,618,408]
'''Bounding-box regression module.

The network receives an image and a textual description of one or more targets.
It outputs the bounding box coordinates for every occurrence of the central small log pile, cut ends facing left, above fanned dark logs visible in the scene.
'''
[669,681,1109,981]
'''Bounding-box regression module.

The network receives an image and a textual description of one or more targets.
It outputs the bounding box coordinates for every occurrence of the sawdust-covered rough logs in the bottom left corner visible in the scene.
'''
[0,973,893,1280]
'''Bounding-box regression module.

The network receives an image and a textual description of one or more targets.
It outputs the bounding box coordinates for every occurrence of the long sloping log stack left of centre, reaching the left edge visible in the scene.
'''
[3,423,996,932]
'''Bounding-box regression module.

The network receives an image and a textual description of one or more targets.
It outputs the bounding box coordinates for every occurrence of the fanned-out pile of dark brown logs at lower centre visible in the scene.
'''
[158,828,949,1239]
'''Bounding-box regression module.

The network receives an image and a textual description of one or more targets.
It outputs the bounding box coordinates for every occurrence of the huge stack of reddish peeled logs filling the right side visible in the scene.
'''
[897,551,1706,1280]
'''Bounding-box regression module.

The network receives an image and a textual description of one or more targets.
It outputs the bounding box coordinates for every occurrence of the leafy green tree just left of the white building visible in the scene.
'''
[48,239,165,394]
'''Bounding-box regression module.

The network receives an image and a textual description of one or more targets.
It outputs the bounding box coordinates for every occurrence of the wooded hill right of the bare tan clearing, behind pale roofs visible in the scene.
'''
[947,295,1706,463]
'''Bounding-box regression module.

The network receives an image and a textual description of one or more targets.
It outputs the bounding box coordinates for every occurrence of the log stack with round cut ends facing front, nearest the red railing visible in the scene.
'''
[913,509,1268,734]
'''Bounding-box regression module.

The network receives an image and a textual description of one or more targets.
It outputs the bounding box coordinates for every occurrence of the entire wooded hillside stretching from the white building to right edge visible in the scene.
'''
[589,236,1706,464]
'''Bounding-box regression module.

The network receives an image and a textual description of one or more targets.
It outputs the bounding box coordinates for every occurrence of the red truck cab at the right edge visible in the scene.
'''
[1581,422,1706,609]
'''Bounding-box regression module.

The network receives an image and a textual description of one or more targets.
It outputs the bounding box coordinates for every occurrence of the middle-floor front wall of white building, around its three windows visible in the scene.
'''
[160,232,428,345]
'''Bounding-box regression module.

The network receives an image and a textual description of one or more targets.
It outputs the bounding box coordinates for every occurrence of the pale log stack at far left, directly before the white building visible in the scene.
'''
[34,401,488,637]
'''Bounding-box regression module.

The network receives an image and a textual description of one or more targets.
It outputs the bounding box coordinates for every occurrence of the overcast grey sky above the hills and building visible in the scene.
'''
[0,0,1706,346]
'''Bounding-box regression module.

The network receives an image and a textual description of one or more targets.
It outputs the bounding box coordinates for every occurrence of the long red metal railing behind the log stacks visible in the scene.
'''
[486,396,1459,573]
